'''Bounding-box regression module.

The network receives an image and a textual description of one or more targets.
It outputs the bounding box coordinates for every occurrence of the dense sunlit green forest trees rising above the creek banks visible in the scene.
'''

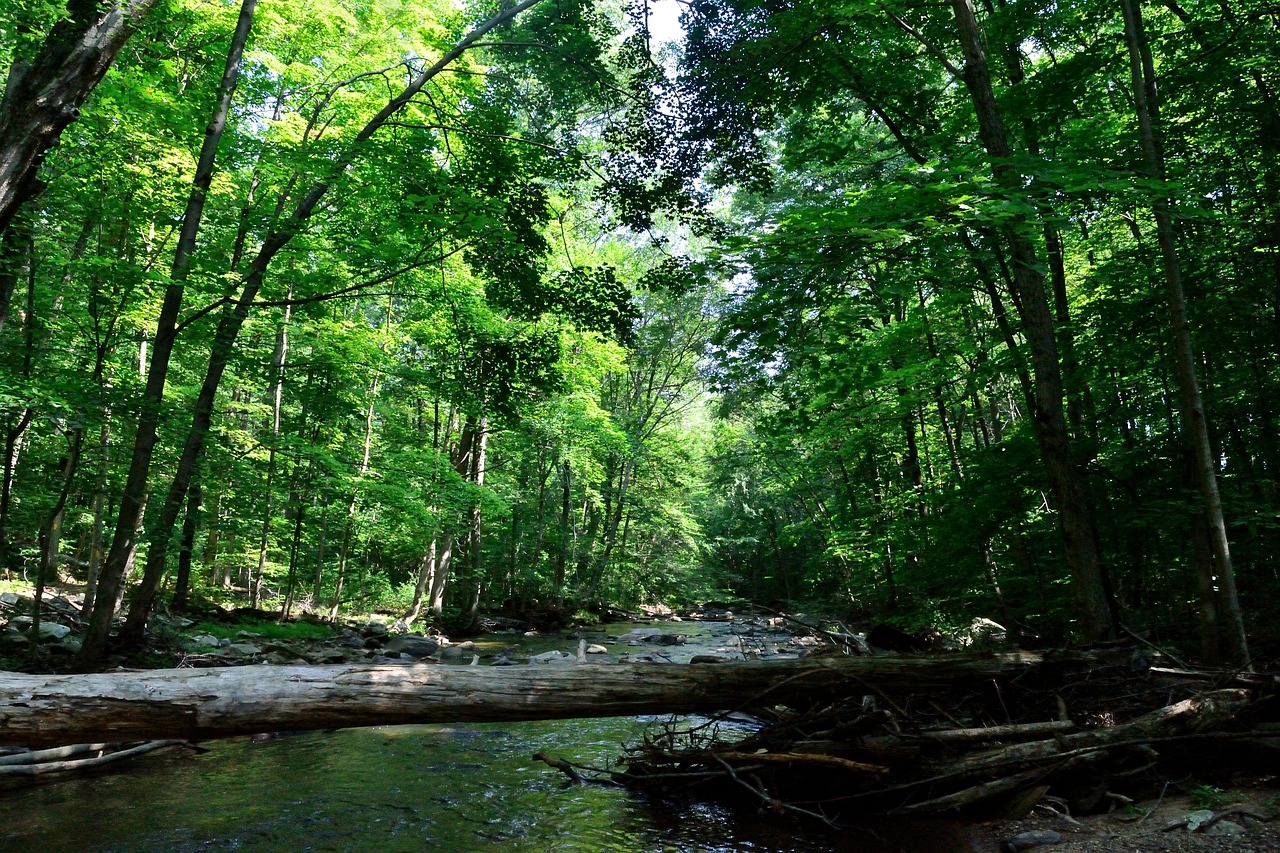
[0,0,1280,667]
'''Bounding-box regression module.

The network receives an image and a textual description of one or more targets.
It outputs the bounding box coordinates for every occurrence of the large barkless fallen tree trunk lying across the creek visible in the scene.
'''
[0,652,1062,747]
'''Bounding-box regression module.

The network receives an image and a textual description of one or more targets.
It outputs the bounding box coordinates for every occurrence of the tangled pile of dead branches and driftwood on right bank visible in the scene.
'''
[549,649,1280,825]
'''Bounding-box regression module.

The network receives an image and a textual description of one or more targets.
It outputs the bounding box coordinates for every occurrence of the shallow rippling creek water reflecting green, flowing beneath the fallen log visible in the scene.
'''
[0,622,972,853]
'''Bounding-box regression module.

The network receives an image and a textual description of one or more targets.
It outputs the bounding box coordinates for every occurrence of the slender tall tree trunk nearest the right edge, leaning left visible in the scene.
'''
[1120,0,1249,667]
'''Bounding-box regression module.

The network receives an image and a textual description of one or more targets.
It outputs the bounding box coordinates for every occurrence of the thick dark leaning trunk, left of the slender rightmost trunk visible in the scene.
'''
[952,0,1114,642]
